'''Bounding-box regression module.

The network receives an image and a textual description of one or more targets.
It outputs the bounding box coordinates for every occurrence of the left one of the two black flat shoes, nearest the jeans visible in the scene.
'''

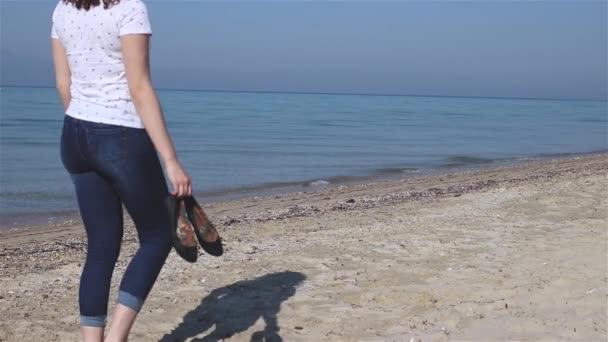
[165,195,198,262]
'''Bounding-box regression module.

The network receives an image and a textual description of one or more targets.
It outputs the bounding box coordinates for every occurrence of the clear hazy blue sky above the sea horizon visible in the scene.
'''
[0,0,608,99]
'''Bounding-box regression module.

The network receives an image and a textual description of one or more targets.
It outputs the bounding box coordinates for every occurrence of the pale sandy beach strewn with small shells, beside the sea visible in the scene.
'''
[0,154,608,342]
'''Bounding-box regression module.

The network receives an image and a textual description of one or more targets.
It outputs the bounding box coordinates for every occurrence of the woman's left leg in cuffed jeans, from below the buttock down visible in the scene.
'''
[71,172,123,342]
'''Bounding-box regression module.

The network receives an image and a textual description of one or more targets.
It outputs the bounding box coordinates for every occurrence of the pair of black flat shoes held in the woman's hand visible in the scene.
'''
[166,195,224,262]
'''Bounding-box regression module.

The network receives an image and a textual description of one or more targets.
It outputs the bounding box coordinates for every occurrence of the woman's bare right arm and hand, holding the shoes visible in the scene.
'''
[120,34,192,196]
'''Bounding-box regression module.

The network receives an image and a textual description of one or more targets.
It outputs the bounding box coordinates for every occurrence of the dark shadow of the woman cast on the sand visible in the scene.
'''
[160,272,306,342]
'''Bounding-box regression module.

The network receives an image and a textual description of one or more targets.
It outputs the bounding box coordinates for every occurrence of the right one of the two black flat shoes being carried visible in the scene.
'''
[184,196,224,256]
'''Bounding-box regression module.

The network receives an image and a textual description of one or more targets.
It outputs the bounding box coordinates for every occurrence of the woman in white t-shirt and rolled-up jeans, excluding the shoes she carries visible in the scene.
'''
[51,0,192,341]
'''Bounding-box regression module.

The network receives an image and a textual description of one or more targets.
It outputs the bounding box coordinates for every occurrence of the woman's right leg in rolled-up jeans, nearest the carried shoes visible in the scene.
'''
[104,129,171,341]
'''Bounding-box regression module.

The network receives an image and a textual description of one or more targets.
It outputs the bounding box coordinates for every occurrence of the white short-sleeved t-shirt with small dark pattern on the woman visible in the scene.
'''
[51,0,152,128]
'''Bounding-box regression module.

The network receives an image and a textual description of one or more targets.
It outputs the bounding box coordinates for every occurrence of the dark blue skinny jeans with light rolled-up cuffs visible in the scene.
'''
[61,115,171,327]
